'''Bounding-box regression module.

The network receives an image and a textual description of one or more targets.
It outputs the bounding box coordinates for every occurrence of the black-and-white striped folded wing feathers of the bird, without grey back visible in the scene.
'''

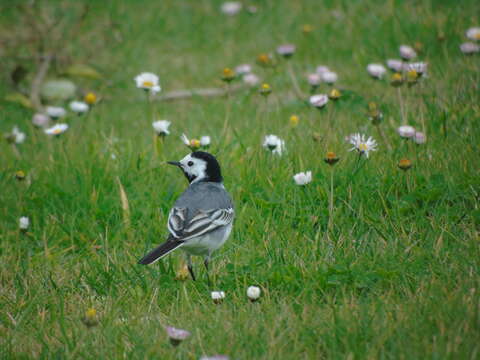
[168,207,235,241]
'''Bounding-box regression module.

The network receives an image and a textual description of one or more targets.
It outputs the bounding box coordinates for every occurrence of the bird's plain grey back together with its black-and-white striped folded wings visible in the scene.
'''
[168,183,235,241]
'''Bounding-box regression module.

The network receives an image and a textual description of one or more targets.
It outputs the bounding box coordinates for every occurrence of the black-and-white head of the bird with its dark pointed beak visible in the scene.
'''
[168,151,223,184]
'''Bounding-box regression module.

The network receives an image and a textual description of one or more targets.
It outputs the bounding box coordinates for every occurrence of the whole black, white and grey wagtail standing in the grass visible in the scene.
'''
[139,151,235,281]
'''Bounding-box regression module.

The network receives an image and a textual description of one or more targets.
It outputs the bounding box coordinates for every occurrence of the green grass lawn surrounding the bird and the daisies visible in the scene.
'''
[0,0,480,359]
